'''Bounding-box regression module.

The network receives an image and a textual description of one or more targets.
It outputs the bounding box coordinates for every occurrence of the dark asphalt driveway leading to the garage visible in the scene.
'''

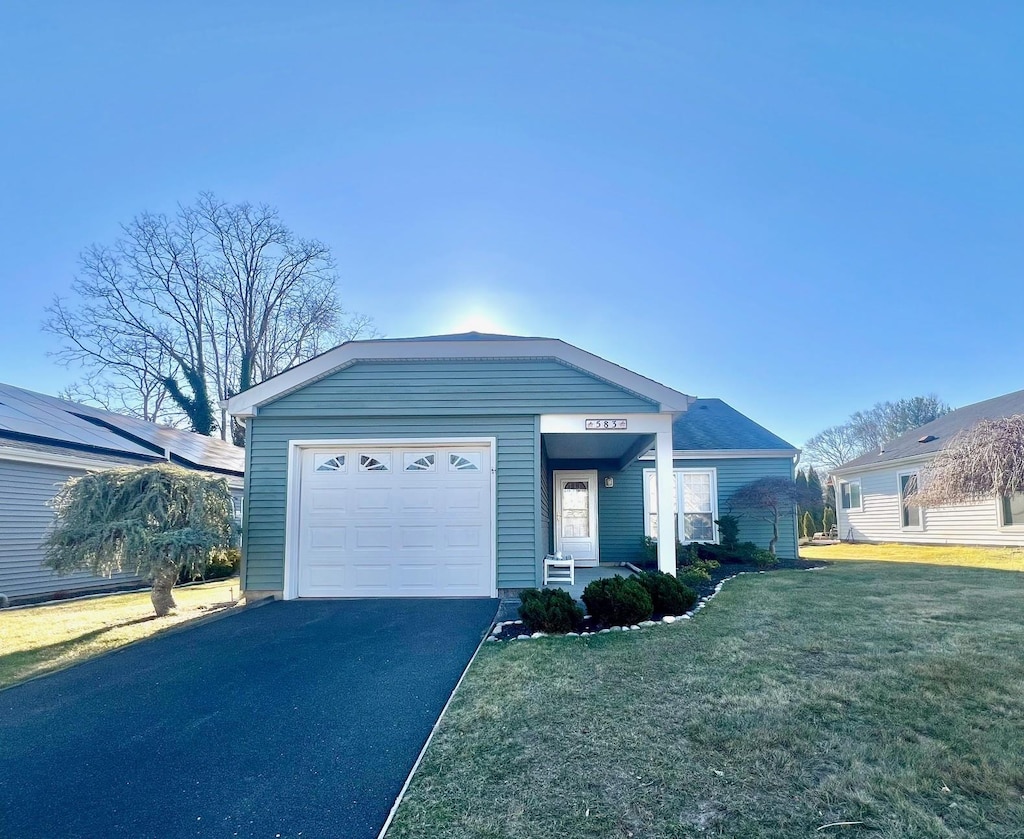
[0,599,498,839]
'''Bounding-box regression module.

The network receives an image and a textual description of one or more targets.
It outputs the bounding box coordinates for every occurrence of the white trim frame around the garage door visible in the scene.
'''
[282,437,498,600]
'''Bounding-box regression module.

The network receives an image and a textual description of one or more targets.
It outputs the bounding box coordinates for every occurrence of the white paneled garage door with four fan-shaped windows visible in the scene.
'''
[297,445,494,597]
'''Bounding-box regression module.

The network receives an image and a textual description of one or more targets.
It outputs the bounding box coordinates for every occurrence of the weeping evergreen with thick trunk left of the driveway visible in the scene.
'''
[44,463,236,617]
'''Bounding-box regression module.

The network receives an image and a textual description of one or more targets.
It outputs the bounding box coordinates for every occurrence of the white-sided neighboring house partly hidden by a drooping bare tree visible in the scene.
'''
[831,390,1024,545]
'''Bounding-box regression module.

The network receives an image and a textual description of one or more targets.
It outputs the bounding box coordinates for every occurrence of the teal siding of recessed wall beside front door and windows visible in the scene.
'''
[598,457,797,562]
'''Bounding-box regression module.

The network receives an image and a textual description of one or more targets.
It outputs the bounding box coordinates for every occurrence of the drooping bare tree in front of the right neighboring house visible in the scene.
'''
[907,414,1024,507]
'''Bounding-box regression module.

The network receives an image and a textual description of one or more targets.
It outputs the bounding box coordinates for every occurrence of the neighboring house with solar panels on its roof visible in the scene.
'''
[0,384,245,602]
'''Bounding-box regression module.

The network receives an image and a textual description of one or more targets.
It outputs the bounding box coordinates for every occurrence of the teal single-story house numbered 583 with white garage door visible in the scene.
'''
[226,333,799,598]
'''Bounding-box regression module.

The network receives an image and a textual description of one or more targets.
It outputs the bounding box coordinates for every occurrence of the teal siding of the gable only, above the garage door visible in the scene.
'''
[259,359,658,417]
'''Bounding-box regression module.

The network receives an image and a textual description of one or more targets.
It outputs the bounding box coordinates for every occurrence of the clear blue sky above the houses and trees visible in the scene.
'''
[0,0,1024,445]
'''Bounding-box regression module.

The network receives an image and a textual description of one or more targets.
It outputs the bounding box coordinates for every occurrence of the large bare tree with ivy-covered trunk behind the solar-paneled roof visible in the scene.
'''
[45,193,376,442]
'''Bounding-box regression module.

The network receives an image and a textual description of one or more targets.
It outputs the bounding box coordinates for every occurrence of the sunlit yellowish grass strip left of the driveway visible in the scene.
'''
[0,577,239,688]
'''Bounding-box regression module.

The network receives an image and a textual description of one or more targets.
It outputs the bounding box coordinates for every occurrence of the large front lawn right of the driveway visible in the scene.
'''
[388,563,1024,839]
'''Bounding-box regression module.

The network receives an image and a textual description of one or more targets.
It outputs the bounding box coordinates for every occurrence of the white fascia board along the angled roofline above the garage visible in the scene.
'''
[227,338,693,417]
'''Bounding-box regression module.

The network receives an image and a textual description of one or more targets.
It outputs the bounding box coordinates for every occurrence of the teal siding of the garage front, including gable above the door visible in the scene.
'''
[243,359,657,591]
